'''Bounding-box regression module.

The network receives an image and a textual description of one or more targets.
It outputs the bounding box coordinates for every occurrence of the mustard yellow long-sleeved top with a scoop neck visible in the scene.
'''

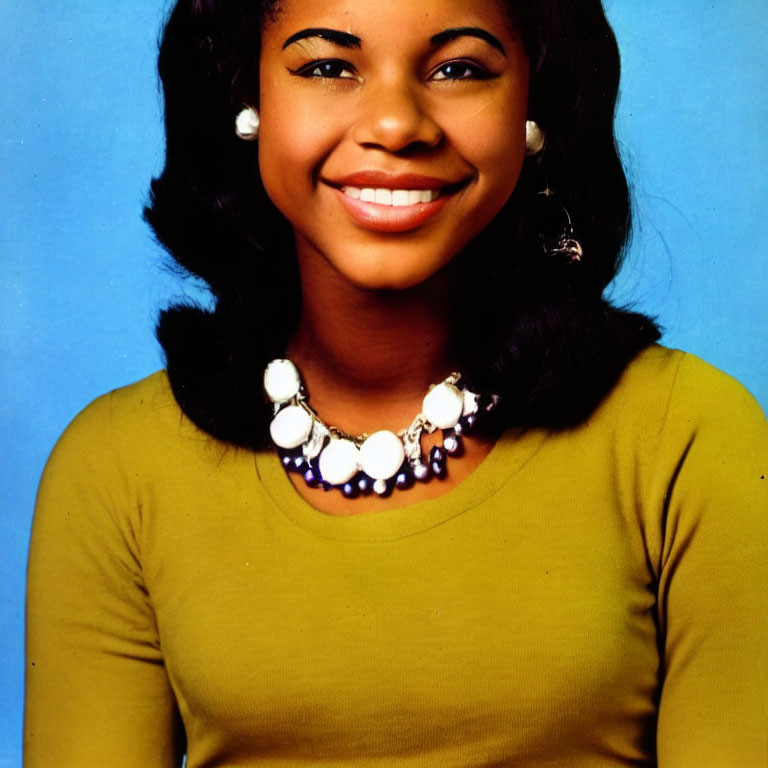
[25,347,768,768]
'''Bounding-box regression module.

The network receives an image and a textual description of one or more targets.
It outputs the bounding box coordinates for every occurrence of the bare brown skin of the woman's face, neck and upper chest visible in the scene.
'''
[259,0,529,514]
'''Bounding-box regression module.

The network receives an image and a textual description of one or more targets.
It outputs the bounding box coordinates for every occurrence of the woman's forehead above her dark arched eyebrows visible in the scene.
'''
[263,0,516,46]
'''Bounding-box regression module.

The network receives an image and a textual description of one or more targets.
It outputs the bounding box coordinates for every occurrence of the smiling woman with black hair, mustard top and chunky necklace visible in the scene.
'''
[25,0,768,768]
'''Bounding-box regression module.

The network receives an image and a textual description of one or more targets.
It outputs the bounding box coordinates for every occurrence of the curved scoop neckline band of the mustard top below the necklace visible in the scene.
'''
[254,429,547,543]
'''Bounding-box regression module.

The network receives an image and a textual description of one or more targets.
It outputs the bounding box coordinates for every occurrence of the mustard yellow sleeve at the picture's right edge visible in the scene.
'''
[658,359,768,768]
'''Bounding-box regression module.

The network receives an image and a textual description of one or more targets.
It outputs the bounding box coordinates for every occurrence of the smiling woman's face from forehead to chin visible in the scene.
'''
[259,0,529,289]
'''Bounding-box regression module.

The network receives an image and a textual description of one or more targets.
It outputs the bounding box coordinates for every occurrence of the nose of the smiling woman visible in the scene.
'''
[353,80,443,152]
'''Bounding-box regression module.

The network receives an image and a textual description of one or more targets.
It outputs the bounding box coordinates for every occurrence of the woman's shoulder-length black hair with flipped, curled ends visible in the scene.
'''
[145,0,659,447]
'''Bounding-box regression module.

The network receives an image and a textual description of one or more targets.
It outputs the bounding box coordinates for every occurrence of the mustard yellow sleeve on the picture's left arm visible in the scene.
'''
[24,396,182,768]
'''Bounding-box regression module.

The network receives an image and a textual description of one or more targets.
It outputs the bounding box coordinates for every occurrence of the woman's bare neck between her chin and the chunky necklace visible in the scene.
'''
[288,256,454,433]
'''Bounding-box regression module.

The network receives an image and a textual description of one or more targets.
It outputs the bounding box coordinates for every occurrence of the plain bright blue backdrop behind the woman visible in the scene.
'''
[0,0,768,767]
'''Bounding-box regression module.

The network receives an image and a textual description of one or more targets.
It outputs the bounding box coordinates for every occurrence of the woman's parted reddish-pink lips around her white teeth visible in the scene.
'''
[325,171,471,233]
